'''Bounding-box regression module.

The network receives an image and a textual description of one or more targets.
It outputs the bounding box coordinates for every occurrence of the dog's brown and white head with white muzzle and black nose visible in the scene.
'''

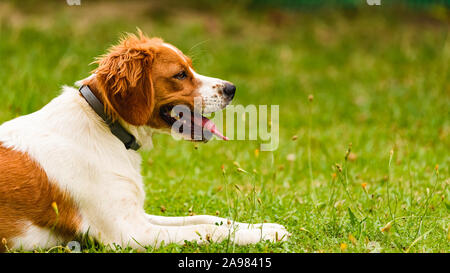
[84,31,236,141]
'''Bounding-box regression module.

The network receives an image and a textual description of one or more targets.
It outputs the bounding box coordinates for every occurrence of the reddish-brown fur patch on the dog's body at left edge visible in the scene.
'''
[0,143,81,252]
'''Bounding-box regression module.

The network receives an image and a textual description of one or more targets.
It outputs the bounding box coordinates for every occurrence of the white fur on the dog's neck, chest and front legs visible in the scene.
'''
[0,87,289,249]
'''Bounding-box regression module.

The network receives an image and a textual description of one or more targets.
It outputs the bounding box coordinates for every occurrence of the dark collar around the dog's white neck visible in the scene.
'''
[79,85,141,151]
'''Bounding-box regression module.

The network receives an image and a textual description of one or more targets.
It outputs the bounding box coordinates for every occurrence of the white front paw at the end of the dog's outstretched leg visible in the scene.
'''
[234,224,291,245]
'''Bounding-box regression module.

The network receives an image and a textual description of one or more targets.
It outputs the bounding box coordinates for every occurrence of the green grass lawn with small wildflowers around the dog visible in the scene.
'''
[0,1,450,253]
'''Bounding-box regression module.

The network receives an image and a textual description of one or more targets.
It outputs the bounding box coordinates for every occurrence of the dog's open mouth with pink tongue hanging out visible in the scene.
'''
[159,105,228,142]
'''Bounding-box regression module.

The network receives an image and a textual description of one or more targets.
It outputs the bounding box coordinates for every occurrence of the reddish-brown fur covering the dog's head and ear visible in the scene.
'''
[83,31,199,128]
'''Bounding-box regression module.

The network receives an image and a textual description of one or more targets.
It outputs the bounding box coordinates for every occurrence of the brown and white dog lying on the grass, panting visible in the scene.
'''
[0,32,289,251]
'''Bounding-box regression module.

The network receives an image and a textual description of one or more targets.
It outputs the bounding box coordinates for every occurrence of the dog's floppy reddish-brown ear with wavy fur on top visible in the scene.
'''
[95,35,154,126]
